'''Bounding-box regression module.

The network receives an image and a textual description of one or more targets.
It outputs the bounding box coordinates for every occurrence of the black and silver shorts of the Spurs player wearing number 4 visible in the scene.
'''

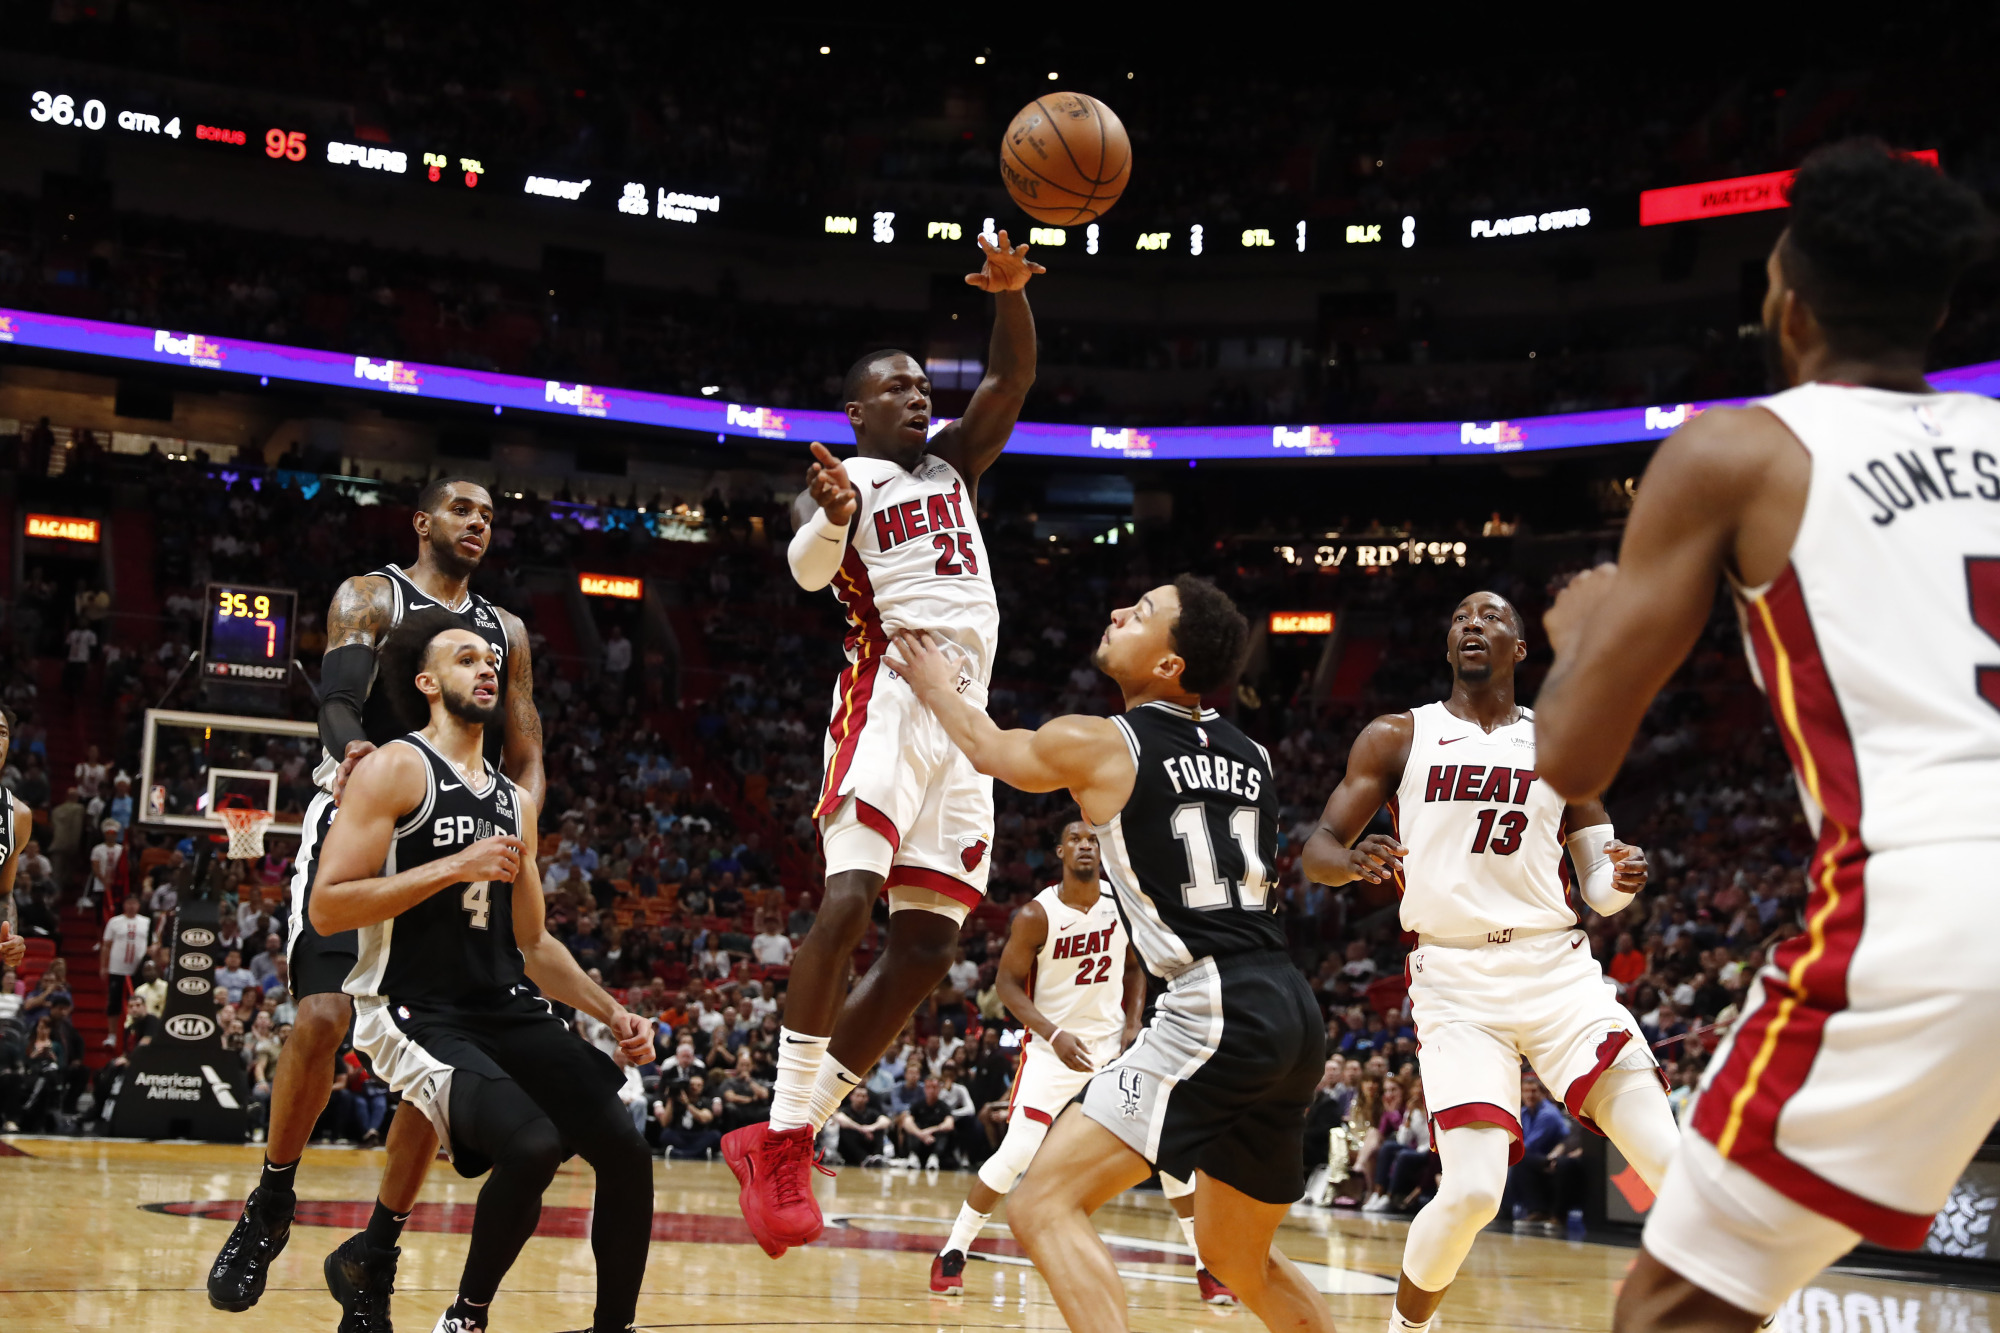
[354,987,624,1177]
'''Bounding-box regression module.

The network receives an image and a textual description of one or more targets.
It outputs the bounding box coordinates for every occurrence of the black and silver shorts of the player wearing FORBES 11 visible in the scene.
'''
[1082,951,1326,1203]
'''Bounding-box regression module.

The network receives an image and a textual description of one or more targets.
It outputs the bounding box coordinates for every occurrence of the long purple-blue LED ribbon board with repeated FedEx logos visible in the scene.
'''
[0,308,2000,464]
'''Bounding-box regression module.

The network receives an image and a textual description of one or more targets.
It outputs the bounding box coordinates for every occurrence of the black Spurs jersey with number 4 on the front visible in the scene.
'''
[342,733,526,1005]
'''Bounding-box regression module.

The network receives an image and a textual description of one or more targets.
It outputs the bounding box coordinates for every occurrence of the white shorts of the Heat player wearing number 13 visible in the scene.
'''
[1408,931,1660,1161]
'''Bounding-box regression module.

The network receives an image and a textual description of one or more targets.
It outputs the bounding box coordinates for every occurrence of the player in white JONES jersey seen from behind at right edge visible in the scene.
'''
[1540,142,2000,1331]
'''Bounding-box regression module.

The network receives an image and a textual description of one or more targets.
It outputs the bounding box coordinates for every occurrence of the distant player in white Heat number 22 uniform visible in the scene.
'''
[930,819,1236,1305]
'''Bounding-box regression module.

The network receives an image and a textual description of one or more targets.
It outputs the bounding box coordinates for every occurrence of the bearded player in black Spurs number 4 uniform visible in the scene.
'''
[312,628,652,1333]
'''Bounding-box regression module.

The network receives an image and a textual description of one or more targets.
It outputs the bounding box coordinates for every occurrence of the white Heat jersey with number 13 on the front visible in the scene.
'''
[1390,703,1576,939]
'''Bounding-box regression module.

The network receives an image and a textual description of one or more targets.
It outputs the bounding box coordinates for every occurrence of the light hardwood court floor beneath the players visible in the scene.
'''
[0,1139,2000,1333]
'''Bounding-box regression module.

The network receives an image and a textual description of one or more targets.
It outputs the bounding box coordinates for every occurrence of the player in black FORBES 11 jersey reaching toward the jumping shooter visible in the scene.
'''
[892,574,1334,1333]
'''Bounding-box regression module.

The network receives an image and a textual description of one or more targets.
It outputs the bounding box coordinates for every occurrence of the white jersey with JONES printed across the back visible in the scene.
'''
[1738,384,2000,851]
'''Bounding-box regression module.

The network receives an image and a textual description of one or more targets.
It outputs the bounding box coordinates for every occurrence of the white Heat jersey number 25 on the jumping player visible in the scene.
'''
[832,454,1000,685]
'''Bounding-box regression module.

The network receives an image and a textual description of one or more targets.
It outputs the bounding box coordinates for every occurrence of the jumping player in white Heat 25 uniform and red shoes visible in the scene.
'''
[722,232,1042,1257]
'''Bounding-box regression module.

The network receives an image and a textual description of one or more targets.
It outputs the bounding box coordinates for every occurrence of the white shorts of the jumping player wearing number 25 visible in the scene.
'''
[814,654,994,921]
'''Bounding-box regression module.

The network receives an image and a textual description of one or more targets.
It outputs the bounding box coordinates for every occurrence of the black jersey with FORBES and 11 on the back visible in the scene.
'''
[1092,703,1284,977]
